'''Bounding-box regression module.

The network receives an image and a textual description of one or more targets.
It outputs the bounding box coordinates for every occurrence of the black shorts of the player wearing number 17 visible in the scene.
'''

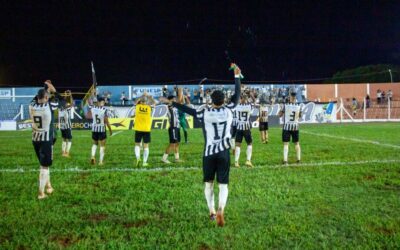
[203,150,231,184]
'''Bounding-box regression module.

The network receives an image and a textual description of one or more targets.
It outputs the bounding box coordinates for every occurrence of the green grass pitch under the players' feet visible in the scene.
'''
[0,123,400,249]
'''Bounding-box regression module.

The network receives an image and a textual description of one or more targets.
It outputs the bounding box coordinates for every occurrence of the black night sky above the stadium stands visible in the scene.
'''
[0,0,400,87]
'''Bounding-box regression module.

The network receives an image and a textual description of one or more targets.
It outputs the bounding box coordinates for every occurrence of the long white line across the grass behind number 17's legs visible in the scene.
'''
[0,159,400,173]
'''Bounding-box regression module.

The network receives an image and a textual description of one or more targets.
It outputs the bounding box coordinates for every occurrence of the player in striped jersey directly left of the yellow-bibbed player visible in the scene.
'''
[90,97,112,166]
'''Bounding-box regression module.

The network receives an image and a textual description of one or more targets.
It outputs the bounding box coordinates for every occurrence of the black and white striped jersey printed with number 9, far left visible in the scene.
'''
[29,101,58,142]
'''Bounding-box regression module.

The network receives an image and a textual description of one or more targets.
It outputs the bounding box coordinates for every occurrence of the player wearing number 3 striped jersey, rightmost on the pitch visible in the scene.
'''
[279,90,302,165]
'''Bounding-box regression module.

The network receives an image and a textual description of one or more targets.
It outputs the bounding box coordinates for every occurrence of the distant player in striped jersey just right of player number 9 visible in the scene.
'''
[58,99,72,157]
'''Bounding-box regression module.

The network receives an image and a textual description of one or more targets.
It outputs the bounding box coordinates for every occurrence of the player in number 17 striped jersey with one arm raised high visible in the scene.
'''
[161,64,241,226]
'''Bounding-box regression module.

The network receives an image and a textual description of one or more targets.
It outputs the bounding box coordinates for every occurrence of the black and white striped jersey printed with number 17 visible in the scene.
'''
[196,106,233,156]
